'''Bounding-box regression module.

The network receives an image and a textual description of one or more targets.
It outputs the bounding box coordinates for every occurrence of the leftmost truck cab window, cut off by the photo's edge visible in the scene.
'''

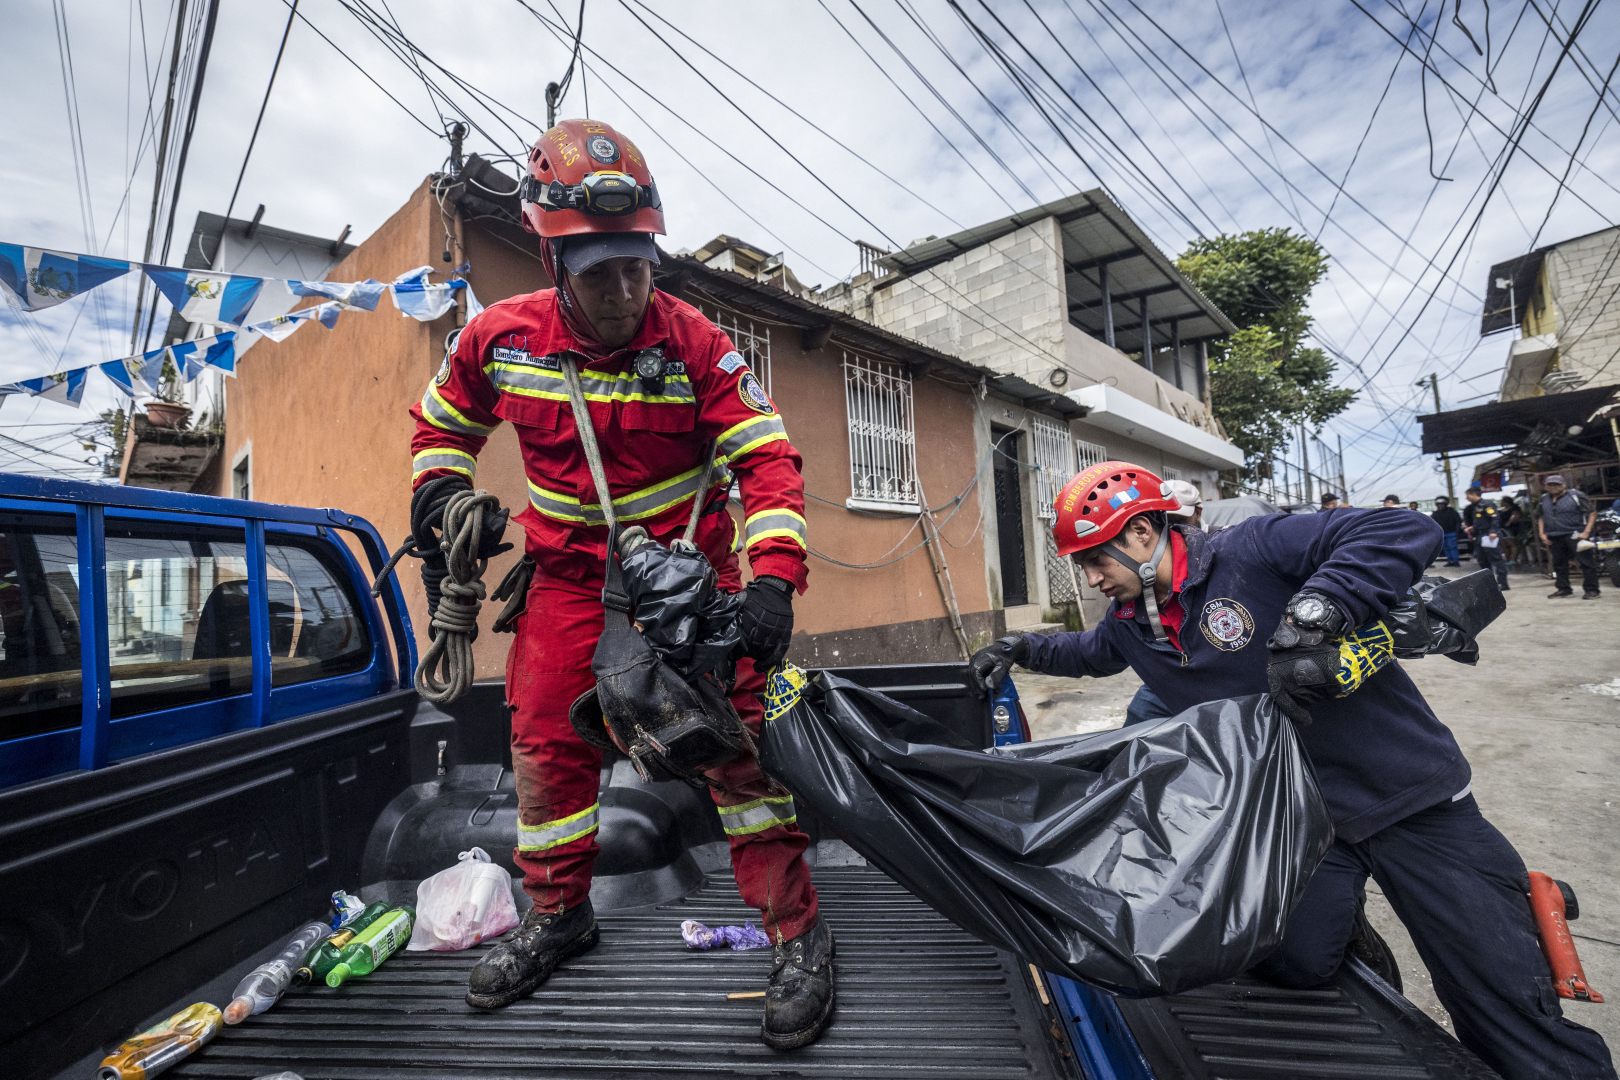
[0,513,81,740]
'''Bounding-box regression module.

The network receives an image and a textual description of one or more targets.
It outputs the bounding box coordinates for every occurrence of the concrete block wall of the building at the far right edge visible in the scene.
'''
[1545,228,1620,385]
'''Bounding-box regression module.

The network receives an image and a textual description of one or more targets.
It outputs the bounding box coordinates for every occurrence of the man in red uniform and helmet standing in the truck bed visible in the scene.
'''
[411,120,834,1049]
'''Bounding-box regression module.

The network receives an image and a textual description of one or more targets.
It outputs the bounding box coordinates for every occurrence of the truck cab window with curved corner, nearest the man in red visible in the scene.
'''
[264,533,371,687]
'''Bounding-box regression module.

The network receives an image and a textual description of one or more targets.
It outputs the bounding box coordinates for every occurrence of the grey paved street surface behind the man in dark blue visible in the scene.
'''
[1017,572,1620,1049]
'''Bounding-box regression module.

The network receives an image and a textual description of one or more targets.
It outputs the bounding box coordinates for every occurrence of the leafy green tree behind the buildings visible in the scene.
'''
[1176,228,1356,482]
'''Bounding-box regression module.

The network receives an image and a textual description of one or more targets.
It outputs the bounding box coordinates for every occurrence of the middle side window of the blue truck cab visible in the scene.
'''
[107,521,253,717]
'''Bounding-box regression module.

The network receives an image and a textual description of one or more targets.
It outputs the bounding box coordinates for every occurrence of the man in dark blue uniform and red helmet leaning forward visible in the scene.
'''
[972,461,1615,1080]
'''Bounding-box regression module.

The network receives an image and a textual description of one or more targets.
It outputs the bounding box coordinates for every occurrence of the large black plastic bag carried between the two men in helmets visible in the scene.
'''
[760,669,1333,996]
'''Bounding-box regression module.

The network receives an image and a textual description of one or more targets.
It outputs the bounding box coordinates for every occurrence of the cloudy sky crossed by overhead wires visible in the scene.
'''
[0,0,1620,505]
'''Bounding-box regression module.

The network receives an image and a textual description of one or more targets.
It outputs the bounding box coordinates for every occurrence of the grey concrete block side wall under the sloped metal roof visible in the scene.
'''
[872,217,1069,382]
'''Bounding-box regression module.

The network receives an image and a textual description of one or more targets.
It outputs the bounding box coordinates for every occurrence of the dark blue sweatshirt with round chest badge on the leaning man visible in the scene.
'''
[1027,510,1469,844]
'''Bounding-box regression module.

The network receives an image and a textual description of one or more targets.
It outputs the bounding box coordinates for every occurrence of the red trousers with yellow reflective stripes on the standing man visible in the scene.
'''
[507,550,816,941]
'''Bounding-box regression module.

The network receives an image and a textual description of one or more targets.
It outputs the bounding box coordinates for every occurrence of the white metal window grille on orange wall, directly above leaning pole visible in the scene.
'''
[844,353,919,505]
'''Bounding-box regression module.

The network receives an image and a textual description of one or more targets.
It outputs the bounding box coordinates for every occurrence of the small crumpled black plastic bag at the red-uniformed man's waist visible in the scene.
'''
[620,529,742,680]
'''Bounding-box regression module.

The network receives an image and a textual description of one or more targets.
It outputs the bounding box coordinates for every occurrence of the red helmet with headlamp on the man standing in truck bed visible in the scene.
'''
[517,120,664,236]
